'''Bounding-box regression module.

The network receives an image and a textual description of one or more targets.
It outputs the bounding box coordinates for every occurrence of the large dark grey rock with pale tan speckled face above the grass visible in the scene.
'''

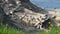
[0,0,54,32]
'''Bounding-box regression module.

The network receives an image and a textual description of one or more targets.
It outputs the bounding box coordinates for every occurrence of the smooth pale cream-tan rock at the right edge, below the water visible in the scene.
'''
[48,9,60,26]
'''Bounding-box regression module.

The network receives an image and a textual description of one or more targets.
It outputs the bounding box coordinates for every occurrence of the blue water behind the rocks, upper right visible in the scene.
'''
[30,0,60,9]
